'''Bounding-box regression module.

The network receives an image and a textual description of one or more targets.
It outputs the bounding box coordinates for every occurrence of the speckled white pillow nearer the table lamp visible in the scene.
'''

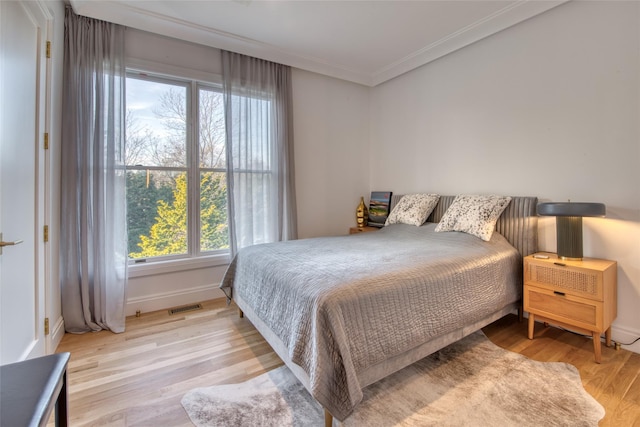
[435,195,511,242]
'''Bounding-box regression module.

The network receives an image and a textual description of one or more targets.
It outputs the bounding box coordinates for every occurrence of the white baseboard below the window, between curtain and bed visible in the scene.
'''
[125,284,225,316]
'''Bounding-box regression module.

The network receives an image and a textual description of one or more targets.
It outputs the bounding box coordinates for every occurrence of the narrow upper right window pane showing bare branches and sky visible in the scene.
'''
[198,88,226,169]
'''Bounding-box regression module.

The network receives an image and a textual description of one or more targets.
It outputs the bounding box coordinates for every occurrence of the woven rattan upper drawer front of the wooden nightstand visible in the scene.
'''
[529,264,602,300]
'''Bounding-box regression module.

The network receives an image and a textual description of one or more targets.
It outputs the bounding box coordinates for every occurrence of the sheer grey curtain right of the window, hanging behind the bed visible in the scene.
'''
[222,51,297,255]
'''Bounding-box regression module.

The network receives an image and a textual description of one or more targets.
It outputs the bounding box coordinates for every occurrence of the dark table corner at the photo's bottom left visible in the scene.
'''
[0,353,70,427]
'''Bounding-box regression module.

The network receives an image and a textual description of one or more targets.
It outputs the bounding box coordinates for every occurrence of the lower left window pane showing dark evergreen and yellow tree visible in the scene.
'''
[127,170,187,258]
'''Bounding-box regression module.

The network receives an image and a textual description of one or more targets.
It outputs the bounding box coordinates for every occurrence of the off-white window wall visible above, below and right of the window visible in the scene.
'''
[126,29,369,315]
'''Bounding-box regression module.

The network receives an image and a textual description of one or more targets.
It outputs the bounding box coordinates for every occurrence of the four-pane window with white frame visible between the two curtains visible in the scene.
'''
[126,72,229,263]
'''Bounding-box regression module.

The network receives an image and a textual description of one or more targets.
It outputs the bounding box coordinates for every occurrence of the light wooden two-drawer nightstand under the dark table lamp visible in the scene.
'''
[523,253,618,363]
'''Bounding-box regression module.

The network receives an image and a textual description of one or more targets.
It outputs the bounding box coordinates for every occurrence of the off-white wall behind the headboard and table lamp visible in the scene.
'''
[370,2,640,352]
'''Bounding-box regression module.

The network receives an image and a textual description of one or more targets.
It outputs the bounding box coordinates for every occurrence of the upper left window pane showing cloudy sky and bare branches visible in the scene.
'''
[126,77,187,167]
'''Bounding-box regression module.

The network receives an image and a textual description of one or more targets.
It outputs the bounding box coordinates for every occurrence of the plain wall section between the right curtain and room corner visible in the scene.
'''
[293,69,369,238]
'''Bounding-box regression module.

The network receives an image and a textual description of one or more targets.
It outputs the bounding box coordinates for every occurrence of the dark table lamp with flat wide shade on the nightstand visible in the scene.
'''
[537,202,606,261]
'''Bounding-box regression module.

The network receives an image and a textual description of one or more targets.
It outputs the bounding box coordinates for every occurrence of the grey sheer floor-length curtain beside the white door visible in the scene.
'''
[60,7,127,333]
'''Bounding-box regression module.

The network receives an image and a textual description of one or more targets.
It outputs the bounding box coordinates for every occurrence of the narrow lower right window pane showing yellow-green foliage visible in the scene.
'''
[200,172,229,252]
